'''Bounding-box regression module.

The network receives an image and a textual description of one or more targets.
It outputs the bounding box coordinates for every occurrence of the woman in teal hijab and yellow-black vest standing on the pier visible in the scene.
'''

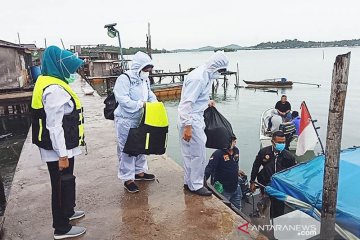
[31,46,86,239]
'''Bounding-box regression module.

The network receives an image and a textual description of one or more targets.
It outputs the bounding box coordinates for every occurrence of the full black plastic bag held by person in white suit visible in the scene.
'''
[204,107,235,149]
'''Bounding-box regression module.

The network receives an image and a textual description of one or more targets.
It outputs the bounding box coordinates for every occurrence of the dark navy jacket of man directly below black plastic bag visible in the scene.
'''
[205,147,239,193]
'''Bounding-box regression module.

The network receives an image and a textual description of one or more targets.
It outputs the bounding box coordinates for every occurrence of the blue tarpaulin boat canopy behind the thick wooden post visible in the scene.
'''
[265,147,360,239]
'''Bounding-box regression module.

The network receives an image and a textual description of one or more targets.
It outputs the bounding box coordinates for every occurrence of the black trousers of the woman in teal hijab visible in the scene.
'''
[47,158,75,234]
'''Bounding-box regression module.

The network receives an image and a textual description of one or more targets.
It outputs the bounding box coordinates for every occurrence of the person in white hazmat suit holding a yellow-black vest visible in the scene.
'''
[114,52,157,193]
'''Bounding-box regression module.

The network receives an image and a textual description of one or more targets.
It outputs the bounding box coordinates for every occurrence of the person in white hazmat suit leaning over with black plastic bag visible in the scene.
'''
[178,52,229,196]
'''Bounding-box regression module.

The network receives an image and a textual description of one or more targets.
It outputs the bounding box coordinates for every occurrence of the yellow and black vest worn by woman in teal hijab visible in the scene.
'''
[31,76,85,150]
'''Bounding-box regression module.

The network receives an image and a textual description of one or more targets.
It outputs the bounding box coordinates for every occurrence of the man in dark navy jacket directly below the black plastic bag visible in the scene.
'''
[205,137,245,210]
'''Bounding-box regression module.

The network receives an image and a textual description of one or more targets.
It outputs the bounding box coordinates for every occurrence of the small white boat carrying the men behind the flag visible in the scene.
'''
[259,108,298,151]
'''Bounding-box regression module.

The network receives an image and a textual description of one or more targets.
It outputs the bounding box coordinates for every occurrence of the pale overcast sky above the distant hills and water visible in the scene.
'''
[0,0,360,50]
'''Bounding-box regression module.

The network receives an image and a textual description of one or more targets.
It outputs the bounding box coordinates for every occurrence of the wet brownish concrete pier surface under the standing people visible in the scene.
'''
[0,78,265,240]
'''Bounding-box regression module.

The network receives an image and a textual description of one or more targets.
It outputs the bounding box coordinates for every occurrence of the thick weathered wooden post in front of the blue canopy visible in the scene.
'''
[320,52,351,240]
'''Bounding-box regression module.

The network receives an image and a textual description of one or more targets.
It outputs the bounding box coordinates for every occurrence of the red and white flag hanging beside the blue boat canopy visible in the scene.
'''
[296,102,318,156]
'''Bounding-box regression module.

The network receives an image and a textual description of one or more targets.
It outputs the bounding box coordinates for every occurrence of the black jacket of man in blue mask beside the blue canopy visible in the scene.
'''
[251,146,296,185]
